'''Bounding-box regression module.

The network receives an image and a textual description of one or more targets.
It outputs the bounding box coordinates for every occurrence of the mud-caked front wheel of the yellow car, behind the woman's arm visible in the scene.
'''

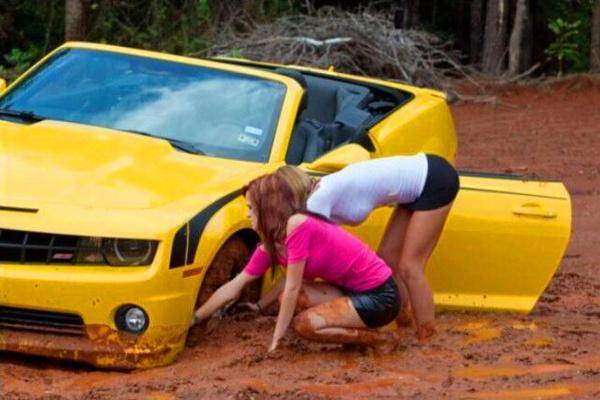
[195,237,261,309]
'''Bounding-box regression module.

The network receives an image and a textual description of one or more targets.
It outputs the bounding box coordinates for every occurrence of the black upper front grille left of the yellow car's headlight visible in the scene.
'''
[0,229,97,264]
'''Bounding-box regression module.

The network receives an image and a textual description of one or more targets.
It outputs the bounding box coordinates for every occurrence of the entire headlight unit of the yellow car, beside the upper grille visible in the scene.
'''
[75,237,158,266]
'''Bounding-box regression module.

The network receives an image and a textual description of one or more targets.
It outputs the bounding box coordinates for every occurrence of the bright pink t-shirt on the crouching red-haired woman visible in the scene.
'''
[244,216,392,292]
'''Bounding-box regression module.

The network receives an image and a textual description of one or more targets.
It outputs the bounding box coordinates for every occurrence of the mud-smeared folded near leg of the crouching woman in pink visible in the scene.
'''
[293,296,396,346]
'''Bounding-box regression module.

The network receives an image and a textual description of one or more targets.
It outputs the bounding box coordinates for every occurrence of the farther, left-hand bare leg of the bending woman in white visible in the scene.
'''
[377,206,413,326]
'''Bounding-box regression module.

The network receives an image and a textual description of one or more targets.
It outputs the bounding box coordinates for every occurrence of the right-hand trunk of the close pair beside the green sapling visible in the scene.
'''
[508,0,533,75]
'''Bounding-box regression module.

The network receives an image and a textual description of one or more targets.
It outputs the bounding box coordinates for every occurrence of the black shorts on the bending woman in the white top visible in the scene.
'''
[402,154,459,211]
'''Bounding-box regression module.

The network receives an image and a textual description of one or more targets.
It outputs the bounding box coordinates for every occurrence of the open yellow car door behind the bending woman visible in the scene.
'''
[307,146,571,312]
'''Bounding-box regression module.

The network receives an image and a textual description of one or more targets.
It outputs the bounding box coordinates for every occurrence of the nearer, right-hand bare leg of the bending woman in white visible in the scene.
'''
[398,204,452,339]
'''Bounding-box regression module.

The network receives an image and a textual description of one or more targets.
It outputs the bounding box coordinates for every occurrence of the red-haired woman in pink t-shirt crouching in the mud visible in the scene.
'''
[194,174,400,351]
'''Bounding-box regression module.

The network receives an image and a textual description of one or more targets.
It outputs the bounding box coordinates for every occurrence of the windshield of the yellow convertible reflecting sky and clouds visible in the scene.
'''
[0,49,285,162]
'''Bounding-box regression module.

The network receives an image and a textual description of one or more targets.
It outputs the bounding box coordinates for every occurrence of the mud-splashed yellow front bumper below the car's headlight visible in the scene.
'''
[0,241,198,369]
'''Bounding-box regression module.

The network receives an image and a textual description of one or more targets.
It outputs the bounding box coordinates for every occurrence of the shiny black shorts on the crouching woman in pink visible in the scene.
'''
[342,276,400,328]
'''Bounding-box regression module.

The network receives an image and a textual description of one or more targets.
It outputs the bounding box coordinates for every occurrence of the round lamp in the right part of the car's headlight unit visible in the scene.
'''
[102,239,156,265]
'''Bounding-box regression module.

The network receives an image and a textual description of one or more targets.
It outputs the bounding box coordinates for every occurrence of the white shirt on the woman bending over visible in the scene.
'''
[306,153,427,225]
